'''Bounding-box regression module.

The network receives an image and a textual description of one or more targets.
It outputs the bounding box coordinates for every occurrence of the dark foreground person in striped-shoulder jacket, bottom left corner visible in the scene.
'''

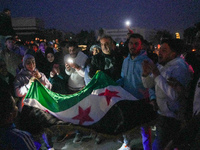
[0,91,36,150]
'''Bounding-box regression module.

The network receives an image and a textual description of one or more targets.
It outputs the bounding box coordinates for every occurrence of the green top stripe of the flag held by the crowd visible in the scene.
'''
[25,71,117,112]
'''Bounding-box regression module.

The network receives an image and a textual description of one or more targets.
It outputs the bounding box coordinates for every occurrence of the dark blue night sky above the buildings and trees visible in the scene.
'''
[0,0,200,33]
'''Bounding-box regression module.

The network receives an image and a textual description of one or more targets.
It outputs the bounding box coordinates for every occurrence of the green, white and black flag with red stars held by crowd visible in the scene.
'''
[24,71,156,134]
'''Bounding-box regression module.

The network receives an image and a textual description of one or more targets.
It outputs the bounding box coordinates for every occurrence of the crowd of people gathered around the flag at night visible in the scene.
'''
[0,10,200,150]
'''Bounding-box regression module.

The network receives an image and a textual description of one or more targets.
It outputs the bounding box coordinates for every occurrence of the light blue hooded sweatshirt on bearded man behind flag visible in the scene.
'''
[117,50,155,99]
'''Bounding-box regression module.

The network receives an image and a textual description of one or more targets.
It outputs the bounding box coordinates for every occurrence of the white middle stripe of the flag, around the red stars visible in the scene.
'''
[24,86,138,126]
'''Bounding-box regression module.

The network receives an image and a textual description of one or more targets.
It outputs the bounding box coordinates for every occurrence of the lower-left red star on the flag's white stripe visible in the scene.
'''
[72,106,94,125]
